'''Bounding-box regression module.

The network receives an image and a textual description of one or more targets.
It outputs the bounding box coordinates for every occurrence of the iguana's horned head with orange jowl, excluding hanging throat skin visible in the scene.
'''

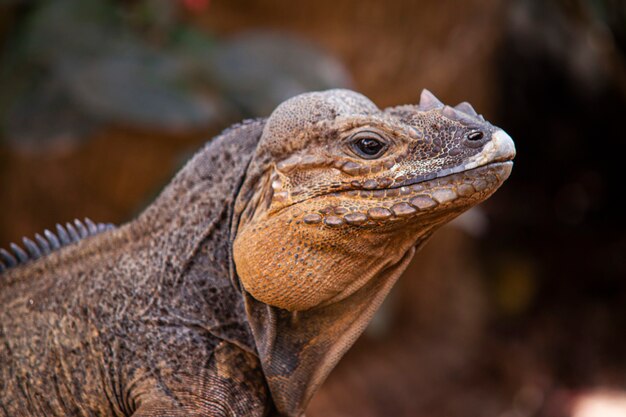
[234,90,515,311]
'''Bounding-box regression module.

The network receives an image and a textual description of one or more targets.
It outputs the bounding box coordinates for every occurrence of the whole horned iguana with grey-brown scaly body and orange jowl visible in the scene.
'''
[0,90,515,417]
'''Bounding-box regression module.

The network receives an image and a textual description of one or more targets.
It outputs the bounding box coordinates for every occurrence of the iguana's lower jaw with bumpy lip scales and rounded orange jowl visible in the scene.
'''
[234,157,512,311]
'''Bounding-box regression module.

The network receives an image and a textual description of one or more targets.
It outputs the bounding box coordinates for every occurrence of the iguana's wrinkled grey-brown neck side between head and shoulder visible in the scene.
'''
[120,120,264,353]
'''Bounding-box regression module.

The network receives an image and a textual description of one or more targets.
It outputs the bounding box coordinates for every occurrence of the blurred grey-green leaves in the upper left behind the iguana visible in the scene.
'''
[0,0,350,150]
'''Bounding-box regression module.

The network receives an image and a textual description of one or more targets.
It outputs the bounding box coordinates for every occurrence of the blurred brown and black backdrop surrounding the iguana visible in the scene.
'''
[0,0,626,417]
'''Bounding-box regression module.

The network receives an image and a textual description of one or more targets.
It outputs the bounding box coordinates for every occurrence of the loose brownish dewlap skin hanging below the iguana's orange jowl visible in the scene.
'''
[239,235,429,416]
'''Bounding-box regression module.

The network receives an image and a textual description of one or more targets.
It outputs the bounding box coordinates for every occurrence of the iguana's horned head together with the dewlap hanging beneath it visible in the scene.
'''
[232,90,515,416]
